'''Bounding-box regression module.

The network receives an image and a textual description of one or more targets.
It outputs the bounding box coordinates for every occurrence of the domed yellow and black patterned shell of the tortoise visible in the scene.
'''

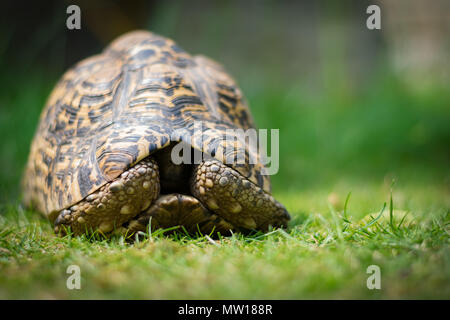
[23,31,270,219]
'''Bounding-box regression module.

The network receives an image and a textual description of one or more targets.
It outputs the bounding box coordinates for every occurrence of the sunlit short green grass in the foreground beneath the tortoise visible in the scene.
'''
[0,182,450,299]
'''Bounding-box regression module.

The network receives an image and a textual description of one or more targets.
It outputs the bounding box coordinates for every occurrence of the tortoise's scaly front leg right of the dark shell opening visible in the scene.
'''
[191,160,290,231]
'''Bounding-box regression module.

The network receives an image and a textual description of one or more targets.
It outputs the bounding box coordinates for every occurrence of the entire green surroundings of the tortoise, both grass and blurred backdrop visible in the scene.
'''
[0,0,450,299]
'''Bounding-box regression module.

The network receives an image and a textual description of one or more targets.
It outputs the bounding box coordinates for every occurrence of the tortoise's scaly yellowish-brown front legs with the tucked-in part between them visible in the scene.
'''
[51,157,290,235]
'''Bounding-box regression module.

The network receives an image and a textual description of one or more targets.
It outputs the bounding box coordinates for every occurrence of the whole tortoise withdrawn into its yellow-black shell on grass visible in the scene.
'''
[22,30,290,235]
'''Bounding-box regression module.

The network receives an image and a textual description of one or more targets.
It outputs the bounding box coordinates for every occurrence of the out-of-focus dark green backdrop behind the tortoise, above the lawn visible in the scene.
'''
[0,1,450,203]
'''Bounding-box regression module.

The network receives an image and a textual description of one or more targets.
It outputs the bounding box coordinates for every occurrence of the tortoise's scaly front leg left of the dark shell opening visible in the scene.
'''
[54,158,160,235]
